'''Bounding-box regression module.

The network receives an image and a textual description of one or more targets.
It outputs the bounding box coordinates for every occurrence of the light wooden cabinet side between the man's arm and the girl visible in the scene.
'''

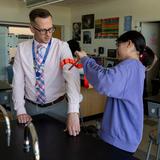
[80,87,106,117]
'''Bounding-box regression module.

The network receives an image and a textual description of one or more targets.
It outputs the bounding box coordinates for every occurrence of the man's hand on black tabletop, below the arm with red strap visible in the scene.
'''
[67,113,80,136]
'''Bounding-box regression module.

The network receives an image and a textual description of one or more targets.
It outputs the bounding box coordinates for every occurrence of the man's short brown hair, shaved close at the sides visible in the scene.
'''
[29,8,52,22]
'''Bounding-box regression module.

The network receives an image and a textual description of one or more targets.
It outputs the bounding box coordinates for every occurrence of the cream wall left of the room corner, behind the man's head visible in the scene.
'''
[0,0,71,40]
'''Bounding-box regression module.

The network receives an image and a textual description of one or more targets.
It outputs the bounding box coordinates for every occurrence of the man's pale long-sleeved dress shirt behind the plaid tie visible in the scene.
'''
[12,38,81,115]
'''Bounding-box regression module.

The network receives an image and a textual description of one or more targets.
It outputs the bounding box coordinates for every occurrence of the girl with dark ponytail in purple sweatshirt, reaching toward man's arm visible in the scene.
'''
[76,31,156,160]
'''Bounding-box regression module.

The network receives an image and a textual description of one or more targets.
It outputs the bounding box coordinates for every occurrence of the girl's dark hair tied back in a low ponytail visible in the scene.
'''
[117,30,155,67]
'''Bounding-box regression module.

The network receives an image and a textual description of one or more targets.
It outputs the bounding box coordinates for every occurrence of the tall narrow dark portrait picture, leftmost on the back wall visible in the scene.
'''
[72,22,81,41]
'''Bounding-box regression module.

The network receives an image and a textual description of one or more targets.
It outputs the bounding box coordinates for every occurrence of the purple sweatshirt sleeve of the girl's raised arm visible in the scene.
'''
[81,56,127,98]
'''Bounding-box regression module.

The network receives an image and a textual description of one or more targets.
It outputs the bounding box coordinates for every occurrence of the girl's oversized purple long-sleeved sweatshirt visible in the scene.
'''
[81,57,145,152]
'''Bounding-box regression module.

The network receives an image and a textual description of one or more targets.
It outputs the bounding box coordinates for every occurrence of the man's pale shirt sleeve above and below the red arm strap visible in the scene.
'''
[61,42,81,113]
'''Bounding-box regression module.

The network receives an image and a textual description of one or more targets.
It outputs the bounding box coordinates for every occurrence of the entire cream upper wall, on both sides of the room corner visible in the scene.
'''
[0,0,160,52]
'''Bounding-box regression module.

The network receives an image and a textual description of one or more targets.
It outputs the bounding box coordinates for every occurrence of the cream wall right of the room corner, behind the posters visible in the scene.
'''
[71,0,160,54]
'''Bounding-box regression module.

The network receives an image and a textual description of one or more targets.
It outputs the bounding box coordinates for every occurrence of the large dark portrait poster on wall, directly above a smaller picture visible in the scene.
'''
[82,14,94,29]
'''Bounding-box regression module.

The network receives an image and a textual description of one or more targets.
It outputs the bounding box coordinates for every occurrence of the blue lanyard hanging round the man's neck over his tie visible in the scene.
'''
[32,40,52,78]
